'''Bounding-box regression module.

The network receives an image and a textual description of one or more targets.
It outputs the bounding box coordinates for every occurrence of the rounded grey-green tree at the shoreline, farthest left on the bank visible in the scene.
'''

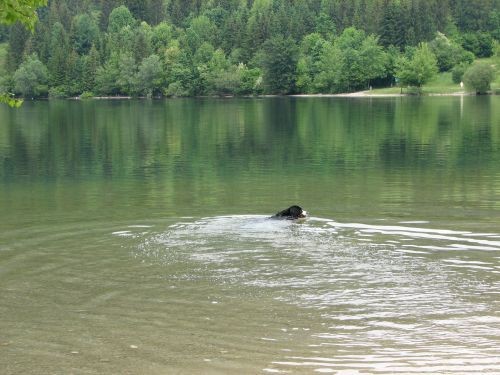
[14,55,48,98]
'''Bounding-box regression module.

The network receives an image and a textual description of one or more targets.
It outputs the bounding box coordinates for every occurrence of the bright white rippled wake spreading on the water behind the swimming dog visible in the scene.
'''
[137,215,500,374]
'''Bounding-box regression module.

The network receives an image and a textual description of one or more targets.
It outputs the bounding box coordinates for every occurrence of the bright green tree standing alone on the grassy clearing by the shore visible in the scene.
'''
[396,43,438,87]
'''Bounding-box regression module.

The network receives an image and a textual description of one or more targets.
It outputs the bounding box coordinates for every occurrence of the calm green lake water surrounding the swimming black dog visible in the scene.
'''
[0,96,500,375]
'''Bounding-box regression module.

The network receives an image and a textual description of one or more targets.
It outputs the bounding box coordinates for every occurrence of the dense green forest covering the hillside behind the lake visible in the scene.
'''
[0,0,500,98]
